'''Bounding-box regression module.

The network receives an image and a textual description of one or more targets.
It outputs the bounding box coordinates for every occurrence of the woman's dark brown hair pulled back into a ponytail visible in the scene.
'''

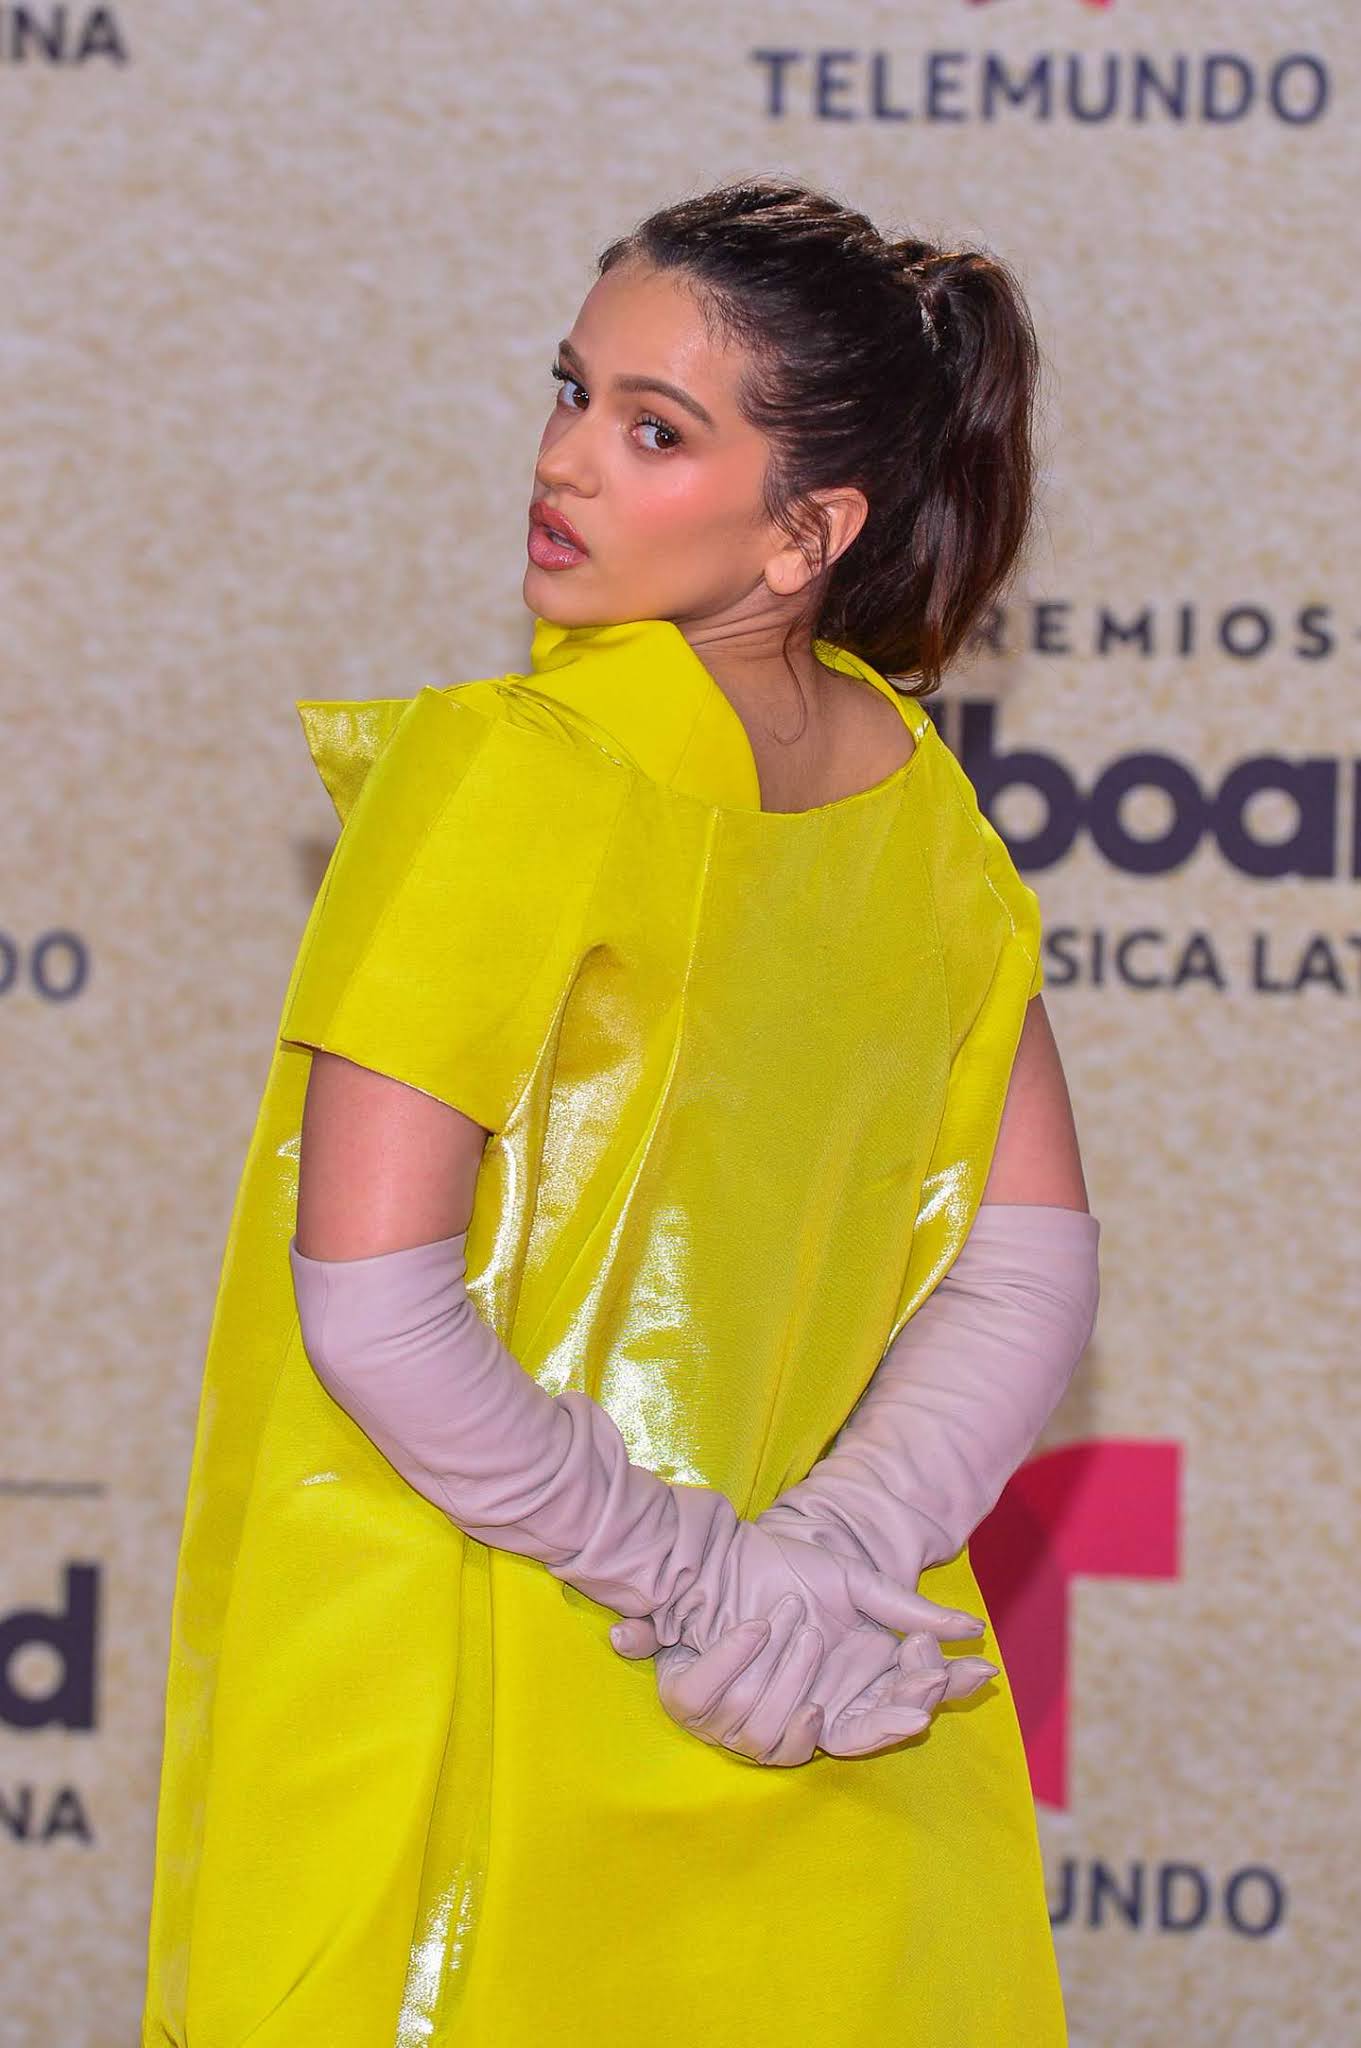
[598,178,1040,696]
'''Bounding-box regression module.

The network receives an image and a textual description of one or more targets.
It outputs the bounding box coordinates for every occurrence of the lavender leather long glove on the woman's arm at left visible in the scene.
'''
[289,1231,978,1679]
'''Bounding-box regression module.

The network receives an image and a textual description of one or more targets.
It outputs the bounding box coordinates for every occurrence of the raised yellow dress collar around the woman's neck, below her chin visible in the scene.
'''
[526,618,901,811]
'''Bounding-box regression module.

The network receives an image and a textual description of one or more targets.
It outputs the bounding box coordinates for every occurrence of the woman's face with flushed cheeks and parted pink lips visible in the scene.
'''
[524,264,806,627]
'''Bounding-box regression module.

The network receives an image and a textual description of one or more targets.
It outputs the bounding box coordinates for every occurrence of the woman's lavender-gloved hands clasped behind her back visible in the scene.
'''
[610,1505,997,1765]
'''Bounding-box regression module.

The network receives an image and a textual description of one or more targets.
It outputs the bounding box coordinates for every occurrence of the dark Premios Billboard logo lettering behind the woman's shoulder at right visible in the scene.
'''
[925,602,1361,997]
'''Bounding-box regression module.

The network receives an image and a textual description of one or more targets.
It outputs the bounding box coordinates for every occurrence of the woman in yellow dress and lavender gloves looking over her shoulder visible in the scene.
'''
[143,180,1097,2048]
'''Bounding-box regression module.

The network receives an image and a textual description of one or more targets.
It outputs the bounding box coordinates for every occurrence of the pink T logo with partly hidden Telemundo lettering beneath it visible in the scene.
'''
[968,1438,1285,1939]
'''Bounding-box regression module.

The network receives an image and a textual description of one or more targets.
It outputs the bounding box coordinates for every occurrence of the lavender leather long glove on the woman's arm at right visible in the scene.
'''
[612,1202,1101,1761]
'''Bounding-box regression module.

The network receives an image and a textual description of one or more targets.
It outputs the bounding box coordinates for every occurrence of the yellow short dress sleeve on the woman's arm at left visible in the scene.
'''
[278,688,618,1133]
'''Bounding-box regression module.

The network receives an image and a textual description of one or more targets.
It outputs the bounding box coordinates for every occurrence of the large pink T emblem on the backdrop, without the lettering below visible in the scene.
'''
[968,1438,1181,1808]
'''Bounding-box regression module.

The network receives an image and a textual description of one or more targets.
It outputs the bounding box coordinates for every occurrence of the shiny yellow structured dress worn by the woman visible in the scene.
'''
[143,618,1066,2048]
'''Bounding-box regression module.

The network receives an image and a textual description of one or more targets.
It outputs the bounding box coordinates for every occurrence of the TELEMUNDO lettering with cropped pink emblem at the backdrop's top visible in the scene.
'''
[749,0,1332,127]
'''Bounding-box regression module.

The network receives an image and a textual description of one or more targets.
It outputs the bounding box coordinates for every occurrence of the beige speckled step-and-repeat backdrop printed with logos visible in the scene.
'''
[0,0,1361,2048]
